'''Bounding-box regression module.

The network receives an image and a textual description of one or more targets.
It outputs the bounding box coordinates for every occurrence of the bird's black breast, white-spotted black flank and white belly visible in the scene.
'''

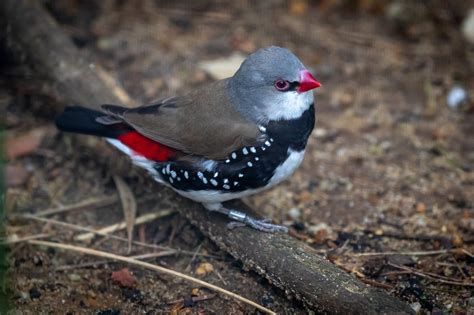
[146,105,315,202]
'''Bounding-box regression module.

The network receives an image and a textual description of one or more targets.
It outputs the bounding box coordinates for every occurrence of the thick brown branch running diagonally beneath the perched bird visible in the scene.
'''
[0,0,413,314]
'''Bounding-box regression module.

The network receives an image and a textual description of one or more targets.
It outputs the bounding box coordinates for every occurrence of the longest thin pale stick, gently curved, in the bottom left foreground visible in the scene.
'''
[28,240,276,315]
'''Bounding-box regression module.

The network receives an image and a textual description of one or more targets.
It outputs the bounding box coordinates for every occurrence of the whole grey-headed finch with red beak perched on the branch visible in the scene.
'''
[56,46,321,233]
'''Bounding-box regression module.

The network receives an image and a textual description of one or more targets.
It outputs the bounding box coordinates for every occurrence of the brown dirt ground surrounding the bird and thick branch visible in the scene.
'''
[0,0,474,314]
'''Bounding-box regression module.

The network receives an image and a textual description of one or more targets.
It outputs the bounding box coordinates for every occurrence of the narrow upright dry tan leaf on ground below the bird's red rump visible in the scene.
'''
[114,176,137,253]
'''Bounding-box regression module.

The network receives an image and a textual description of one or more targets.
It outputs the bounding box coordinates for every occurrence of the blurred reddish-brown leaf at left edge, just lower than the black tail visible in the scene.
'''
[5,127,47,160]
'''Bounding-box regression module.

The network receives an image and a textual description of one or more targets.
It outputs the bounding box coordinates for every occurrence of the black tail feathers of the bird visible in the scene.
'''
[56,106,131,138]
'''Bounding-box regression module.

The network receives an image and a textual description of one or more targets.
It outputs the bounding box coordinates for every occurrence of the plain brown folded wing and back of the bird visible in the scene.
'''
[117,80,260,159]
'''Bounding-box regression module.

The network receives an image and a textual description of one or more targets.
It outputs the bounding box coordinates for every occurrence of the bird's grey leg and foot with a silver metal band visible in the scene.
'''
[203,203,288,233]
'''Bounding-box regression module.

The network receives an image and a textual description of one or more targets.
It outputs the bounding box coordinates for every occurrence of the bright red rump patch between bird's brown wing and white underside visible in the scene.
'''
[118,131,176,162]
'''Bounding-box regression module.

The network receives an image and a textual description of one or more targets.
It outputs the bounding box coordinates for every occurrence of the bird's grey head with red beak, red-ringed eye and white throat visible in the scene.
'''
[227,46,320,124]
